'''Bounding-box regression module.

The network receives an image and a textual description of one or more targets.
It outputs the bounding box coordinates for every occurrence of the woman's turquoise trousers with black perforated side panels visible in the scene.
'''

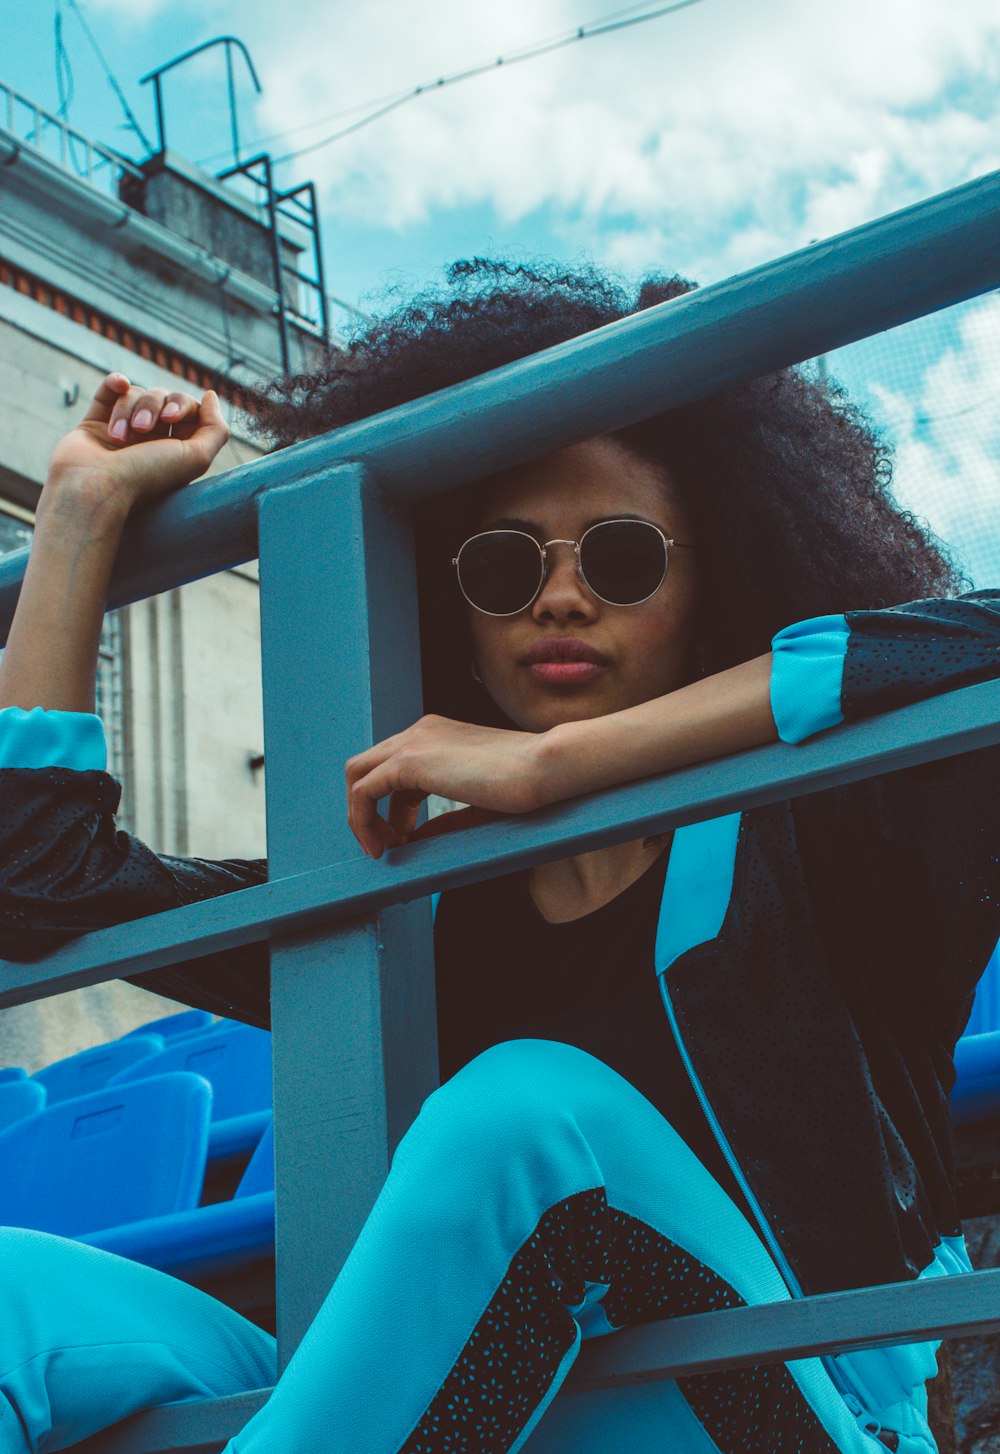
[0,1040,933,1454]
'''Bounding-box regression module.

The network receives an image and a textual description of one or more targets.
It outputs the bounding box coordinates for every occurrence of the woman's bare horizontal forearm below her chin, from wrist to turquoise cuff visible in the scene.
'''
[539,653,778,801]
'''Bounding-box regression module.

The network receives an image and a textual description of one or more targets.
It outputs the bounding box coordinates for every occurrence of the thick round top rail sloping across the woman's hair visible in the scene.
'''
[0,172,1000,640]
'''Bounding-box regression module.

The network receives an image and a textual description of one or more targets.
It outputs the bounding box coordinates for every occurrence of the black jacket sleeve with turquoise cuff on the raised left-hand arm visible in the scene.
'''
[0,708,269,1027]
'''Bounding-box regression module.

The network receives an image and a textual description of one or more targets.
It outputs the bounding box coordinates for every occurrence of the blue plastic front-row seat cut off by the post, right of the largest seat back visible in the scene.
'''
[78,1125,275,1278]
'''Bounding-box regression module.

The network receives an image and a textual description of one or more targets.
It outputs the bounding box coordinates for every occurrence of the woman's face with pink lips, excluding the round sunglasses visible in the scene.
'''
[468,436,698,731]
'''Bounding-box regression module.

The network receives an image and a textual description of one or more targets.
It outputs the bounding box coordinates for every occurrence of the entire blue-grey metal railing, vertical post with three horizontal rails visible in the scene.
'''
[0,165,1000,1454]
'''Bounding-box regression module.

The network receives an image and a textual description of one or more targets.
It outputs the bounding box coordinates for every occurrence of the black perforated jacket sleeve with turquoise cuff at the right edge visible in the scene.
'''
[772,590,1000,1034]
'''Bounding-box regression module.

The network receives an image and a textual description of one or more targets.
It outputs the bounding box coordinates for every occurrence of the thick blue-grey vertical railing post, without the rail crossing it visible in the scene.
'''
[259,467,438,1364]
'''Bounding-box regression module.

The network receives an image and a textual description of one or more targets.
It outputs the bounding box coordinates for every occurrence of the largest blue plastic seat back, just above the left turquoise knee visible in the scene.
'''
[0,1075,212,1237]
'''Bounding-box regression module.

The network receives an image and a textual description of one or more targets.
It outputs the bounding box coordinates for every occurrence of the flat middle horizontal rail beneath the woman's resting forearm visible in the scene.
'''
[0,680,1000,1006]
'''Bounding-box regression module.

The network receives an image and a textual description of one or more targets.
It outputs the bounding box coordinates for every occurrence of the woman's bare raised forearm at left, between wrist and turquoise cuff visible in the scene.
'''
[0,478,128,712]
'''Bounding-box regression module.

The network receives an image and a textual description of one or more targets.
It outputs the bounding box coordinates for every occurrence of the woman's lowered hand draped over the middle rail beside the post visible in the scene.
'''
[346,717,554,858]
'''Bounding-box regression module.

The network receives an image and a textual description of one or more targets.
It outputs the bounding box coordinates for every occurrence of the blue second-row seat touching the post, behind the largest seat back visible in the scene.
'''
[109,1024,272,1160]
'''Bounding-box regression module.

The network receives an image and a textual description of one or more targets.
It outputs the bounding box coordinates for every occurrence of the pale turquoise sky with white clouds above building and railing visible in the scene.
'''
[0,0,1000,583]
